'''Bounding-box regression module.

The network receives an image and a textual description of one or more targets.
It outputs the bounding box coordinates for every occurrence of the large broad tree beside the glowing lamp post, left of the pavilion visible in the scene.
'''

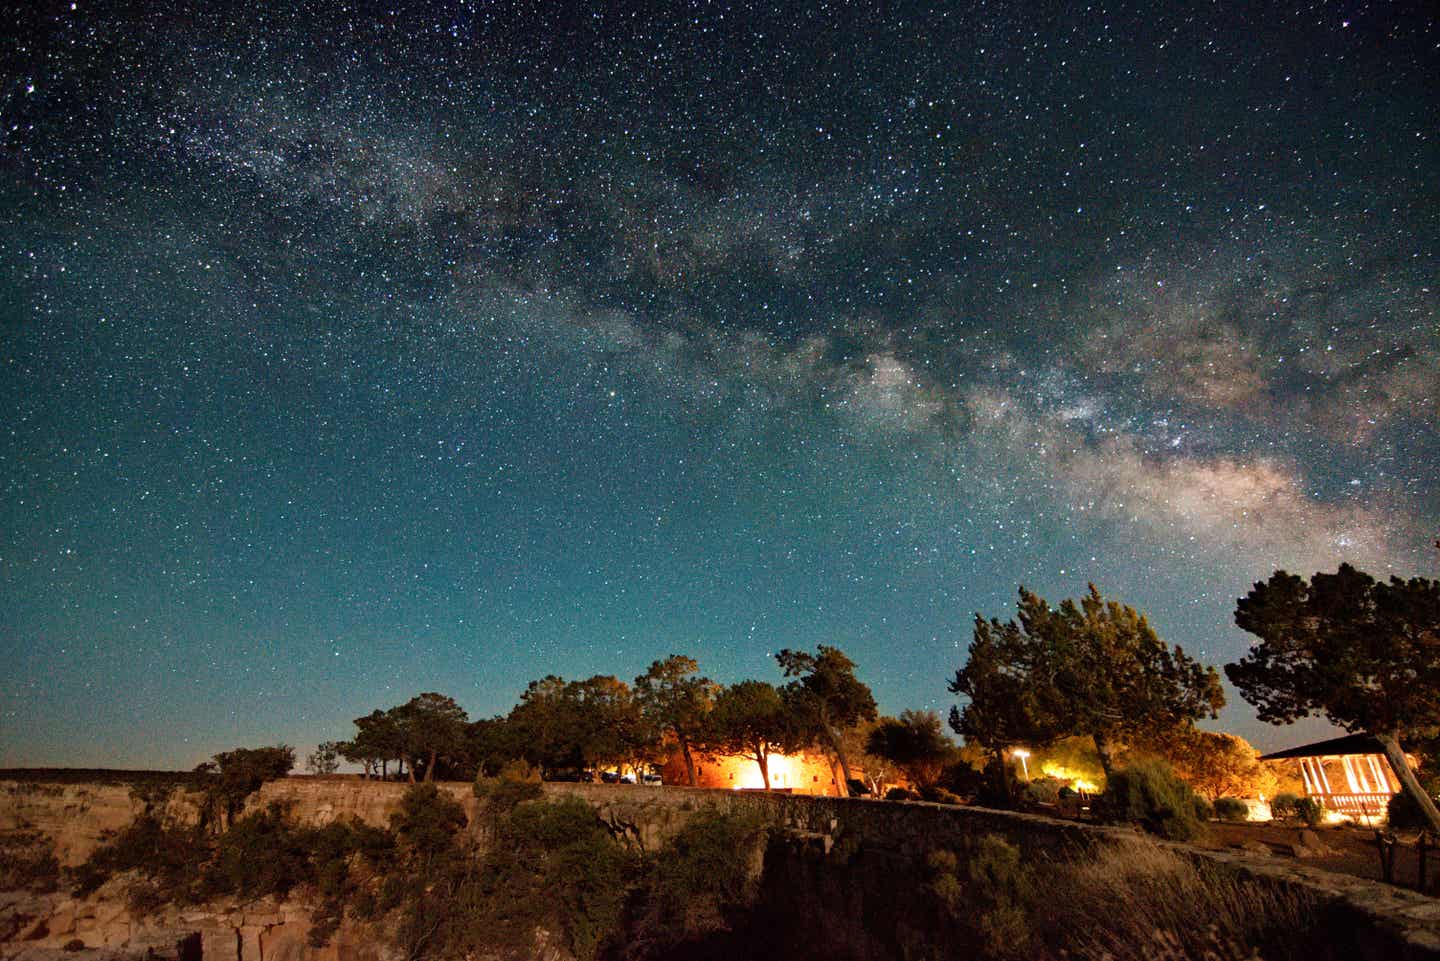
[950,584,1225,779]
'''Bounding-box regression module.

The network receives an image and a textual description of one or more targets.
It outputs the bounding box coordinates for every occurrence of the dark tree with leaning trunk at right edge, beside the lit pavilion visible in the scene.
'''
[1225,563,1440,831]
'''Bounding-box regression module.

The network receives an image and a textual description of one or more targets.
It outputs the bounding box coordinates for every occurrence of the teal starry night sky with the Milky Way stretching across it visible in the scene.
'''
[0,0,1440,766]
